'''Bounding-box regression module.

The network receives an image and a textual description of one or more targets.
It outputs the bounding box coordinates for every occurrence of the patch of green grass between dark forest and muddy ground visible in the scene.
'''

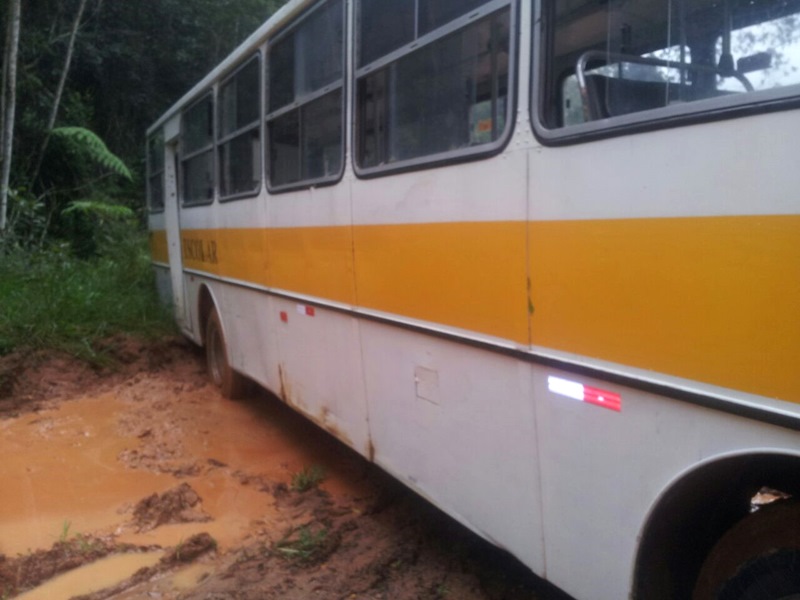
[0,233,174,364]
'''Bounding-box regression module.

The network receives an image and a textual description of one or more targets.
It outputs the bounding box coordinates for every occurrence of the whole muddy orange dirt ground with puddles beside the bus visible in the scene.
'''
[0,338,562,600]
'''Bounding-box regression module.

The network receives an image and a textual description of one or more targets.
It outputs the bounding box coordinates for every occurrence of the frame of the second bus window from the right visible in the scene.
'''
[350,0,521,179]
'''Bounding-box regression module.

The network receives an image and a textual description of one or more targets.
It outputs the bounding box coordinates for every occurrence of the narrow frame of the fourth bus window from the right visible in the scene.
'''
[214,49,265,203]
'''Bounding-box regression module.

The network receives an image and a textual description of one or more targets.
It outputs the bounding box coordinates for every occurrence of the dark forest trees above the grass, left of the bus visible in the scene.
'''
[0,0,285,245]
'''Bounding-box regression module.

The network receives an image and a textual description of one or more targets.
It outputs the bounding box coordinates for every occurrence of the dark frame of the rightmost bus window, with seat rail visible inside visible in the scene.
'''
[529,0,800,146]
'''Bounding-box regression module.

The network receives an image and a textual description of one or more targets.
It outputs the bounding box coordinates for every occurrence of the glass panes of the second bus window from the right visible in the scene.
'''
[356,0,512,169]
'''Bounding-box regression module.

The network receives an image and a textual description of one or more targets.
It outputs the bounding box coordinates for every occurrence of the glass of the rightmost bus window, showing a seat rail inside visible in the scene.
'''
[543,0,800,128]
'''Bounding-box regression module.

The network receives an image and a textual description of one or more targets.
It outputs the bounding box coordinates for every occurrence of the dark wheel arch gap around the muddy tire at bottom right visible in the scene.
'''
[632,450,800,600]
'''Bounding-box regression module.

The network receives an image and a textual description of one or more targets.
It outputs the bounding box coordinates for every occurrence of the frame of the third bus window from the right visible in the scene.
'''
[261,0,350,194]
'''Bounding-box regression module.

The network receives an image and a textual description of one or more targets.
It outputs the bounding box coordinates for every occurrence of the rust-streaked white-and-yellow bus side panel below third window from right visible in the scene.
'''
[261,178,370,456]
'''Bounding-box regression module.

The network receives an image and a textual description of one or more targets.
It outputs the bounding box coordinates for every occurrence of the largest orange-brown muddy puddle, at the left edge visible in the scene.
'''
[0,396,172,556]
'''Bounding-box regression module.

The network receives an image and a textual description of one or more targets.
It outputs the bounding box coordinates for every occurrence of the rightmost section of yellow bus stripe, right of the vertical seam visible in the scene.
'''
[529,215,800,402]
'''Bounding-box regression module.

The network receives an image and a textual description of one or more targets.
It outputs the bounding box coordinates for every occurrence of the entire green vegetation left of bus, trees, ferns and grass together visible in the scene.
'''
[0,0,284,364]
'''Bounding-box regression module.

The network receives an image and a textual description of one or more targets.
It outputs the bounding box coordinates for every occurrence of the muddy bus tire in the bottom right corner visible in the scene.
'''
[693,501,800,600]
